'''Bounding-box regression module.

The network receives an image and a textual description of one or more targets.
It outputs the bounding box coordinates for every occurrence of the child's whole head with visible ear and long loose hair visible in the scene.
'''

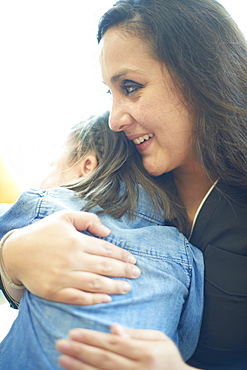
[41,112,187,230]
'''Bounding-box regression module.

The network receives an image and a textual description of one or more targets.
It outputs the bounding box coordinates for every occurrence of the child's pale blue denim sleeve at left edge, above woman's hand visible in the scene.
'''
[0,189,45,239]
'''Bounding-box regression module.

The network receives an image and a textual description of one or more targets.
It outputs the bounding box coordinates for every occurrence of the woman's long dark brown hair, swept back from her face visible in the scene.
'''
[98,0,247,189]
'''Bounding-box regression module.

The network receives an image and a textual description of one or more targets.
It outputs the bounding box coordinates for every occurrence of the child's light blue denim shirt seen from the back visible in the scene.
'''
[0,188,204,370]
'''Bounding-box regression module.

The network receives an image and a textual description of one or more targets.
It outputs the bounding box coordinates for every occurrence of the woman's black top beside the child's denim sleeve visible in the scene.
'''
[188,183,247,370]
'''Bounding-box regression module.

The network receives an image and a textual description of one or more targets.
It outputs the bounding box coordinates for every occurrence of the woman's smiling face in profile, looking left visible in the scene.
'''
[100,27,194,176]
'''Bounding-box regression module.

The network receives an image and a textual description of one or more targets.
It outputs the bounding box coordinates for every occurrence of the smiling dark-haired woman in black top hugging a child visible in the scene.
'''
[0,0,247,370]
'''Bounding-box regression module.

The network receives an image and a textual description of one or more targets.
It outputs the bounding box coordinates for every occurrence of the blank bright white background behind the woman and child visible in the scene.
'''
[0,0,247,189]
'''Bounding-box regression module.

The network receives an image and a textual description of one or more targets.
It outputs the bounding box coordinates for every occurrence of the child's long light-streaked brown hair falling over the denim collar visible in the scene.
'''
[64,112,187,232]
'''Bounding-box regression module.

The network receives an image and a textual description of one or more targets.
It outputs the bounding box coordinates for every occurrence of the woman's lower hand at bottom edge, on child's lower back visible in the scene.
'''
[57,324,195,370]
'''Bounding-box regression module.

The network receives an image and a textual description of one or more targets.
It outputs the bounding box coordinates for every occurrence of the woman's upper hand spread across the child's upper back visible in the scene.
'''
[2,211,140,305]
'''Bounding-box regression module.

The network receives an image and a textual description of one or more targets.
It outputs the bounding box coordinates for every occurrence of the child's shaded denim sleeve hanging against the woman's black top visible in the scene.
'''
[178,242,204,356]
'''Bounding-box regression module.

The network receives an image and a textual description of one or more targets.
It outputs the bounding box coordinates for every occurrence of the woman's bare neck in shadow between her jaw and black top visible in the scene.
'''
[173,163,214,224]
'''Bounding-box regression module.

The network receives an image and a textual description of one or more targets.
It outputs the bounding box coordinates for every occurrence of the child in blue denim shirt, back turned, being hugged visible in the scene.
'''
[0,113,203,370]
